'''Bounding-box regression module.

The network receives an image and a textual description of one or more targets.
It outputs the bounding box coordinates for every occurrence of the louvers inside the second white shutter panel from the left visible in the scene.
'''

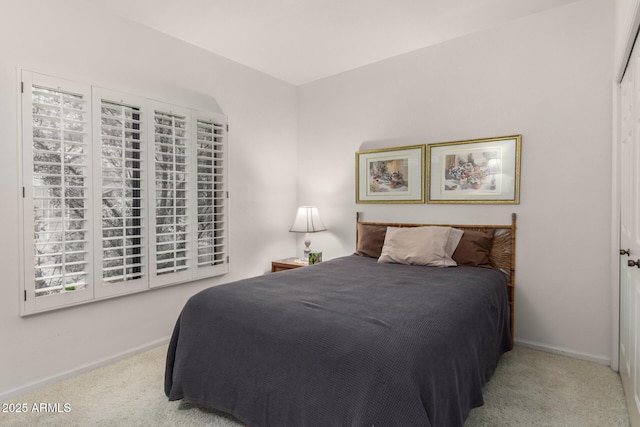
[100,99,145,283]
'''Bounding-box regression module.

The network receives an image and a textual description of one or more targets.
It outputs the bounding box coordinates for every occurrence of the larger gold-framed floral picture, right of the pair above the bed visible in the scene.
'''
[427,135,522,204]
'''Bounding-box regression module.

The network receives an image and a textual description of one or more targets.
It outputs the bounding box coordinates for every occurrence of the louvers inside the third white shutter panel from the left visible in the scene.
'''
[154,111,192,275]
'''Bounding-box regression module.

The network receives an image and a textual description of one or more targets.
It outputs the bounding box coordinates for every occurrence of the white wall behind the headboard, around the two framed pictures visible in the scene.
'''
[298,0,614,363]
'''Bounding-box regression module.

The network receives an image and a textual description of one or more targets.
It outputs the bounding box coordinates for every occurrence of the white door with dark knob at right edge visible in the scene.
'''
[618,34,640,427]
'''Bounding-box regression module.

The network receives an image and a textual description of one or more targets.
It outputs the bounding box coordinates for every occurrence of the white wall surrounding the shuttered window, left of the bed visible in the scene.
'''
[0,0,297,400]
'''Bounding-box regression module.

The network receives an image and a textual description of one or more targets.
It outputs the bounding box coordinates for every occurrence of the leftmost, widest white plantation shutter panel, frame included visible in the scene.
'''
[22,72,93,313]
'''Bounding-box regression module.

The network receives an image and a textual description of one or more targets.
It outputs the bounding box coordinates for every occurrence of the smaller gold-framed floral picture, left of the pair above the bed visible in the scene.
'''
[356,145,425,203]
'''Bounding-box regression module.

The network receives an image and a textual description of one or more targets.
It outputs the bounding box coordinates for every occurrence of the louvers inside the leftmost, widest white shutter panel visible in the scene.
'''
[31,85,92,297]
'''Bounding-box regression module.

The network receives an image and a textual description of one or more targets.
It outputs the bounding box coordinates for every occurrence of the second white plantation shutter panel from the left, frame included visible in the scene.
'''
[94,90,148,297]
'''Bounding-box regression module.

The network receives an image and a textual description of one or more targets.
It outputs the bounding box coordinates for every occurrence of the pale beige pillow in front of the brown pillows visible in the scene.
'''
[378,226,462,267]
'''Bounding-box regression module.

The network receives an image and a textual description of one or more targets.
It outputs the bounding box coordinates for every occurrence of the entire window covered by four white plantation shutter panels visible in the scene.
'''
[22,71,228,314]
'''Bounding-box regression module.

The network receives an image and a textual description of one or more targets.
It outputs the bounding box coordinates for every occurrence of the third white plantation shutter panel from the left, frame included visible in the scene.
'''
[149,103,195,286]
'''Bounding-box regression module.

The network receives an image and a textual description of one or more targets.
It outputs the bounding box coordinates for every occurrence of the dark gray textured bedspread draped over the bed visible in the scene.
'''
[165,255,512,427]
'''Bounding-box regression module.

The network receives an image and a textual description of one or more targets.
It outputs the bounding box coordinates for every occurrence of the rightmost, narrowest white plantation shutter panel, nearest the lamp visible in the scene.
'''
[195,115,228,277]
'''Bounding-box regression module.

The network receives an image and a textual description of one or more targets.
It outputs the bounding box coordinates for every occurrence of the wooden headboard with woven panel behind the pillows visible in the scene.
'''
[356,212,516,339]
